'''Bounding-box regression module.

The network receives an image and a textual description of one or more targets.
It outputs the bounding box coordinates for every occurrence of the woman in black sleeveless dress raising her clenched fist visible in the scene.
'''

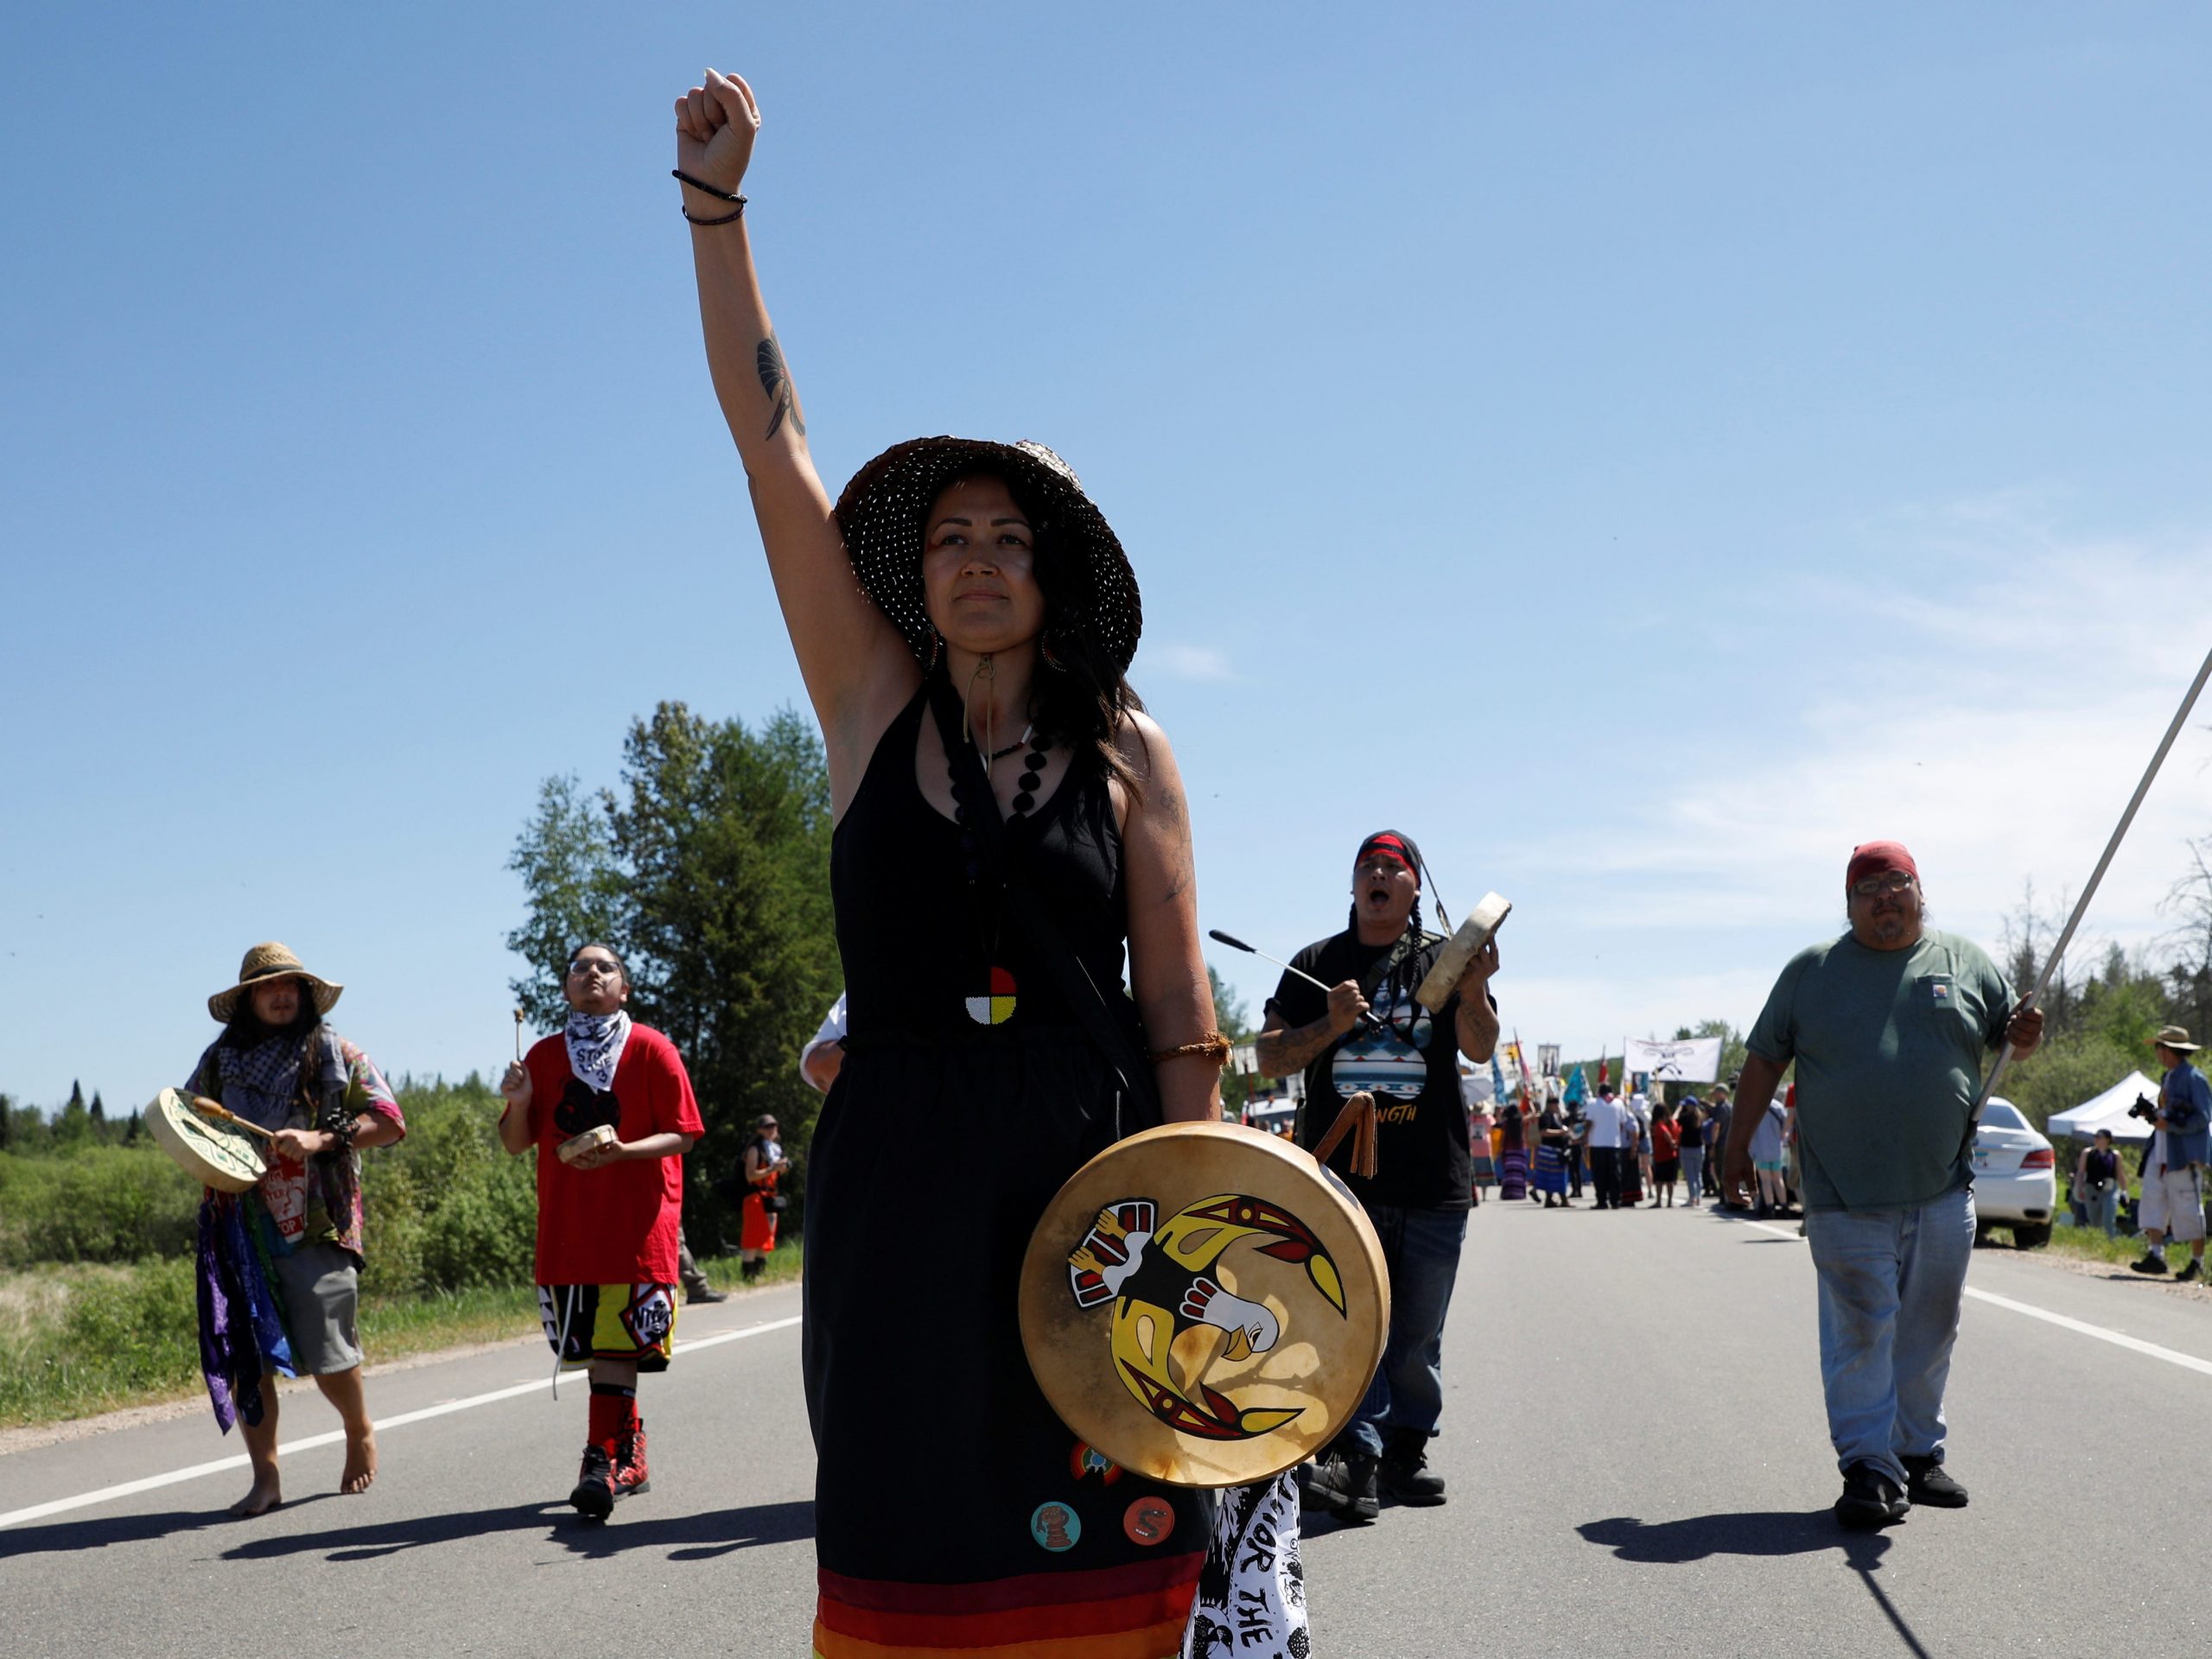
[677,71,1307,1659]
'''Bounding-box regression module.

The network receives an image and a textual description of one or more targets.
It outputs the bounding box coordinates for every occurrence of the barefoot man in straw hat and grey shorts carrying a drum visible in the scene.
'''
[186,943,407,1516]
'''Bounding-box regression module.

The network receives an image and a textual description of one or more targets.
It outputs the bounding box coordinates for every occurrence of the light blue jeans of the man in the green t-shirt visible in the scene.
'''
[1805,1188,1974,1486]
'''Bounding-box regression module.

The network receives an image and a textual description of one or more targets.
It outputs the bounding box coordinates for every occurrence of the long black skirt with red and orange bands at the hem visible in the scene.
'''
[801,1028,1221,1659]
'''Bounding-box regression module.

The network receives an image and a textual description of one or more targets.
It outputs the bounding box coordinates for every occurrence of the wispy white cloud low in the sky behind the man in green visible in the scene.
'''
[1516,512,2212,1039]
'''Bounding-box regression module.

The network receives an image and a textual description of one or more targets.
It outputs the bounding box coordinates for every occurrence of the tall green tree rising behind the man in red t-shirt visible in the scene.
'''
[506,703,842,1241]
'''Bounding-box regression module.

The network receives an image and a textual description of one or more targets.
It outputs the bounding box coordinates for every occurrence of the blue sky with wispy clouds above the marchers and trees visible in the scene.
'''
[0,4,2212,1106]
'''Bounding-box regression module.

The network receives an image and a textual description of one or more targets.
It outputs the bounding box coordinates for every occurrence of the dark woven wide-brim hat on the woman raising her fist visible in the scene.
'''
[836,435,1144,672]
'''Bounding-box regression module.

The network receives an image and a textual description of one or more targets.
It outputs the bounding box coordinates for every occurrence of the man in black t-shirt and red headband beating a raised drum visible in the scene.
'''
[1259,830,1497,1520]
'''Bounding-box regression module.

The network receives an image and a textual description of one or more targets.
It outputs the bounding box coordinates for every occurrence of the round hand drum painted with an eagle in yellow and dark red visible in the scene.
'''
[1022,1123,1389,1486]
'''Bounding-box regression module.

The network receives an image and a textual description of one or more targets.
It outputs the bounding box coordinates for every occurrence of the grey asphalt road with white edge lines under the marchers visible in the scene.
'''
[0,1204,2212,1659]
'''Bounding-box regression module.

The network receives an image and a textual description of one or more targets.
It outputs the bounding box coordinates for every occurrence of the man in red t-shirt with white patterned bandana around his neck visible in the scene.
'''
[500,944,706,1520]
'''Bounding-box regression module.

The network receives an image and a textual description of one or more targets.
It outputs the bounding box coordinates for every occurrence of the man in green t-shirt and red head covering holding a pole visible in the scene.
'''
[1721,841,2044,1526]
